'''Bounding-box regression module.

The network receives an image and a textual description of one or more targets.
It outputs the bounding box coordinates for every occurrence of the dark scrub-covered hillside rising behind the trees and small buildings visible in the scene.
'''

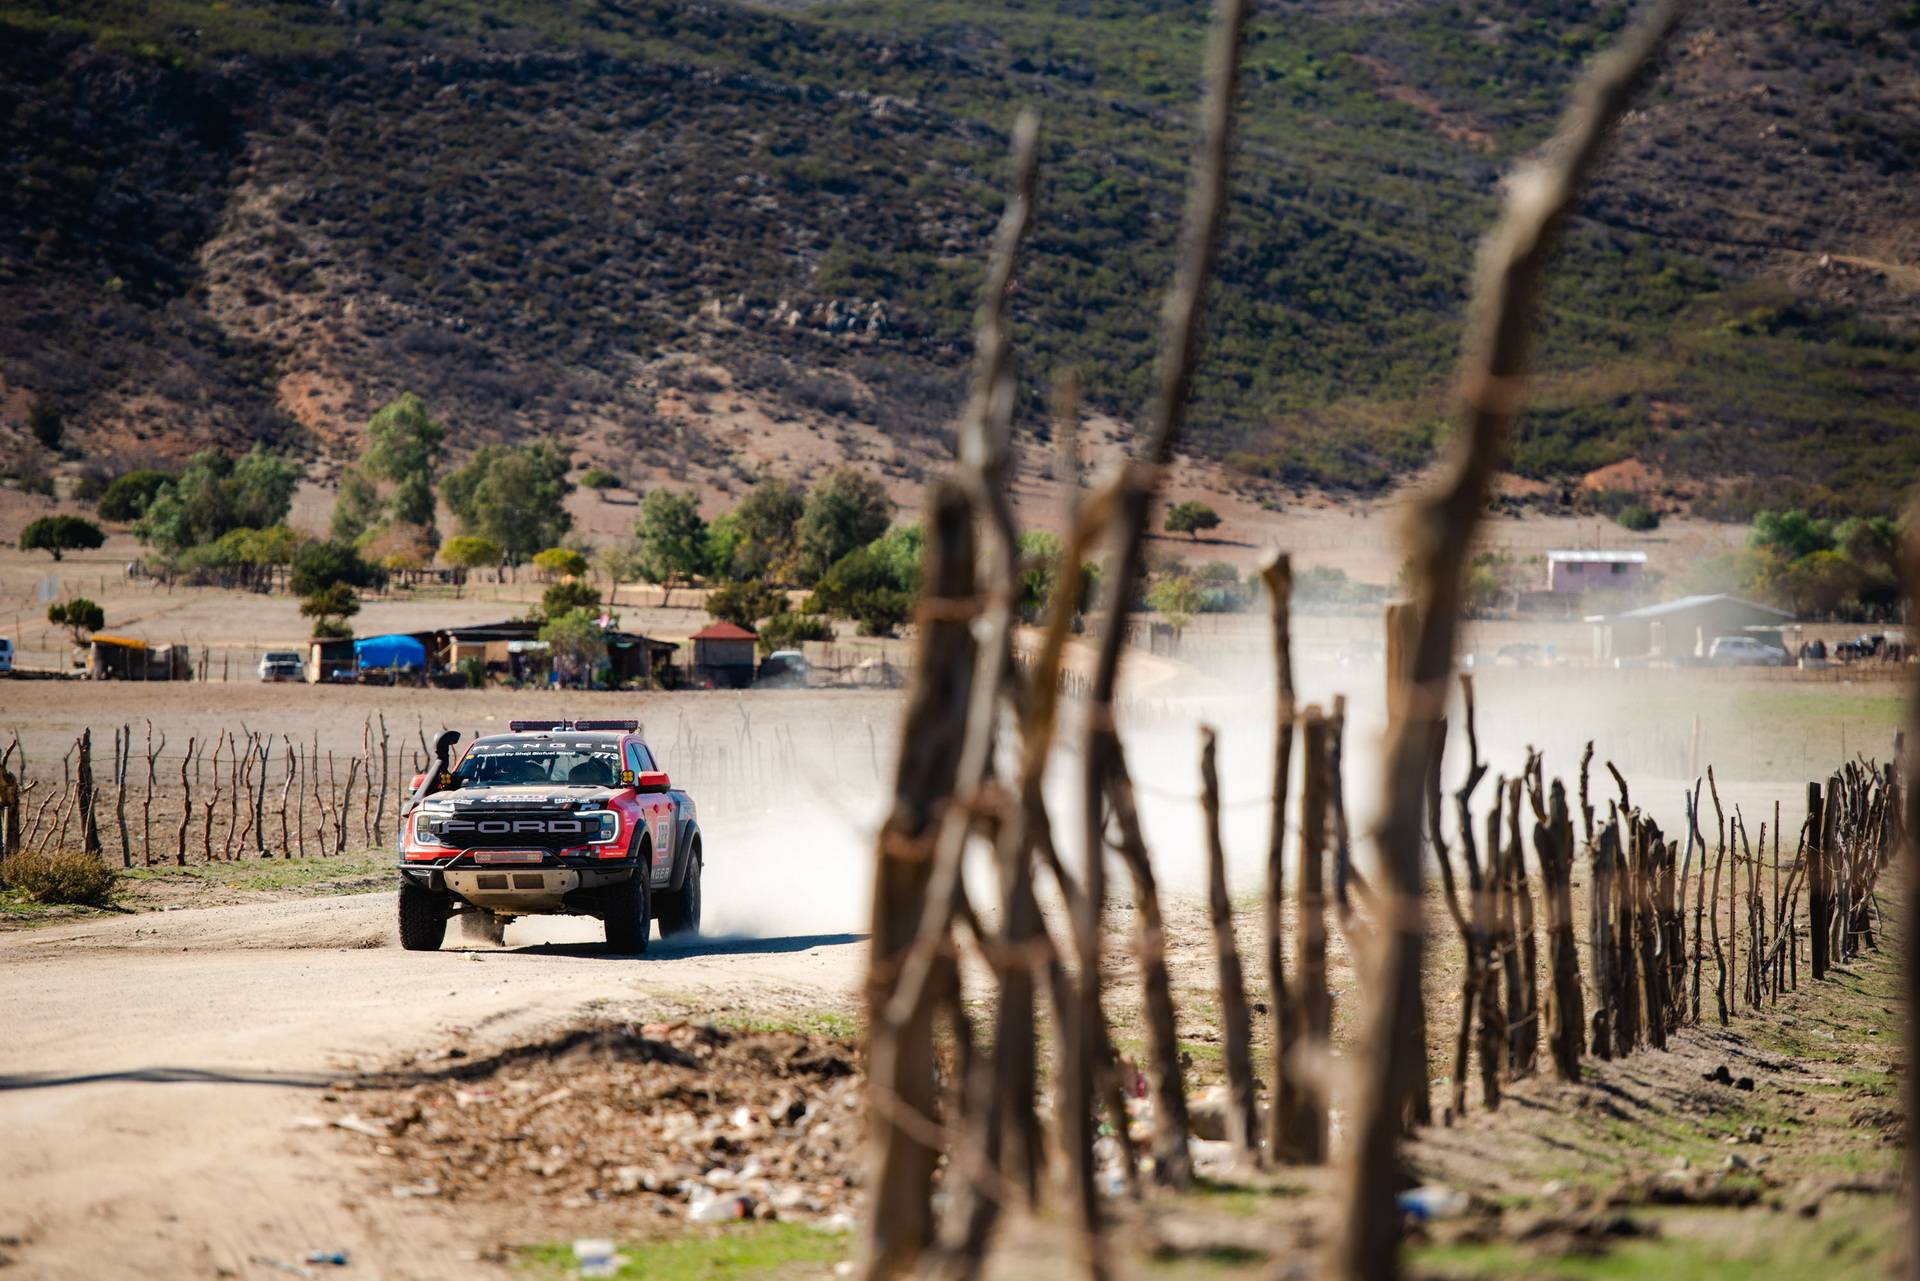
[0,0,1920,515]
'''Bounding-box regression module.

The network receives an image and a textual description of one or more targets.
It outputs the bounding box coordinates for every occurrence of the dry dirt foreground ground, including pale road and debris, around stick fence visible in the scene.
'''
[0,871,1907,1281]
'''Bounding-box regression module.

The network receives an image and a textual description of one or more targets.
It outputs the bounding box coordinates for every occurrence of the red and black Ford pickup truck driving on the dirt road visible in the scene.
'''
[399,720,703,955]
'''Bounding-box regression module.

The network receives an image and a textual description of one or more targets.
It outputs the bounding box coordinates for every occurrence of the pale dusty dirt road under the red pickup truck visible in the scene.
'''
[0,893,862,1281]
